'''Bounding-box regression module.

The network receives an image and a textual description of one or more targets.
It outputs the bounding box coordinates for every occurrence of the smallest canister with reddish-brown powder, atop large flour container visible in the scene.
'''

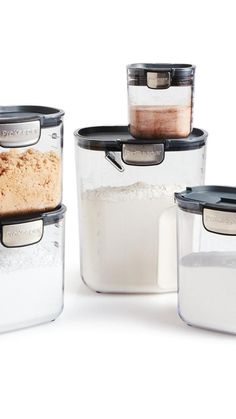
[127,64,195,139]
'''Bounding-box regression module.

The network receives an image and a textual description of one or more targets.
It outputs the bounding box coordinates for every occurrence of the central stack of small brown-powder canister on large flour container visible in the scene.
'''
[75,64,207,293]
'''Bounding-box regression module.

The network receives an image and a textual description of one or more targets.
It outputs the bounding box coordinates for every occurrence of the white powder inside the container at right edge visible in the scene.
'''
[179,252,236,333]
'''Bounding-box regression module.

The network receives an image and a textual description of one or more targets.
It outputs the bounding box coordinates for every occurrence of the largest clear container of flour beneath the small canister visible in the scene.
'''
[75,126,207,293]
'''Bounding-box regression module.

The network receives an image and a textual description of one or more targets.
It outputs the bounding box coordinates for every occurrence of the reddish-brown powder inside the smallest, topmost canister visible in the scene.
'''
[130,106,191,138]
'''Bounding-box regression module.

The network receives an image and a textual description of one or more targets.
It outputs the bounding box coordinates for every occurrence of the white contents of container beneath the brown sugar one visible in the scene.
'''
[0,240,63,332]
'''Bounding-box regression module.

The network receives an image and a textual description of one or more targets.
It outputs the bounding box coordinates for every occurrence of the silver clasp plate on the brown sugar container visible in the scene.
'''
[0,120,40,148]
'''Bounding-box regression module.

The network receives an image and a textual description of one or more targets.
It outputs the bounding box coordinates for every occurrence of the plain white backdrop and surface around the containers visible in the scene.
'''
[0,0,236,419]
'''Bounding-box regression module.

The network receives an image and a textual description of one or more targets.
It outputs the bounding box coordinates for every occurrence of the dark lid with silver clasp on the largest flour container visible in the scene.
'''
[74,126,207,172]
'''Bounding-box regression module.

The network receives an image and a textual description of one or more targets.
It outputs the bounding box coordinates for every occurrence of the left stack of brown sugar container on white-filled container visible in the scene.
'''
[0,106,65,331]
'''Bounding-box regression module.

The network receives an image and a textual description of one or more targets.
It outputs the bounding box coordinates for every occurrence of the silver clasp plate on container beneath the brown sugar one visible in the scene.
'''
[2,220,43,247]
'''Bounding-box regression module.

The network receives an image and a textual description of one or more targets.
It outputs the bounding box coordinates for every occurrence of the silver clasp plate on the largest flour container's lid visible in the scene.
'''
[122,143,165,166]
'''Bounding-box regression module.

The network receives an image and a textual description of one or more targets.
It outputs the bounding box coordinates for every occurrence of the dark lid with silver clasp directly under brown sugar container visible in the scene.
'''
[0,205,66,248]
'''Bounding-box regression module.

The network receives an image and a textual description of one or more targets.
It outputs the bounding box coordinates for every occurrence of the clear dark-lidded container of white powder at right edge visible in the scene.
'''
[176,186,236,333]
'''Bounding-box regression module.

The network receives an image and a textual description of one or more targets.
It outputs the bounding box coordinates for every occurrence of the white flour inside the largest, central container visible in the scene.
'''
[80,182,183,292]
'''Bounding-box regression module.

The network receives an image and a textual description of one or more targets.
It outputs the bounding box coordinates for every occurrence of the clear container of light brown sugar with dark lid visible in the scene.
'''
[0,106,64,217]
